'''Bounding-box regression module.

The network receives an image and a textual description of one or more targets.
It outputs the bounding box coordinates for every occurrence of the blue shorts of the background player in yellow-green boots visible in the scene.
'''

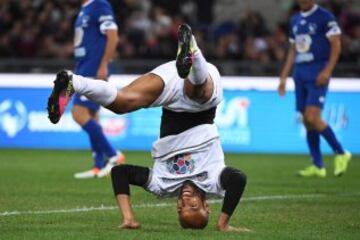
[293,62,328,112]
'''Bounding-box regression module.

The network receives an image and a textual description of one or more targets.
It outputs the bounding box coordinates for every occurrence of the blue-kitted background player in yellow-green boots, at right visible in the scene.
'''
[278,0,351,177]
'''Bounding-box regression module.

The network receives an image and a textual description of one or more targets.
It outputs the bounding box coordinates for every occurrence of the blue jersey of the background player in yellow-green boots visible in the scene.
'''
[289,5,341,64]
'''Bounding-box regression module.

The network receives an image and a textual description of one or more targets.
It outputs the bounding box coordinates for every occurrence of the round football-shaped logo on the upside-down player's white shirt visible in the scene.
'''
[166,153,195,175]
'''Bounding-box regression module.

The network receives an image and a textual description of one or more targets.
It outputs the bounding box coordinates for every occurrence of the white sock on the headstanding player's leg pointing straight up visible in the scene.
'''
[188,36,209,85]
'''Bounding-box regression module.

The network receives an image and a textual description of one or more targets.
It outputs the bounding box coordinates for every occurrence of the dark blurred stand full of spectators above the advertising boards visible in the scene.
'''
[0,0,360,76]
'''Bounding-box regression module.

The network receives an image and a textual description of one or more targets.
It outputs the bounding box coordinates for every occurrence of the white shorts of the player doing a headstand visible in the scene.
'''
[150,61,223,112]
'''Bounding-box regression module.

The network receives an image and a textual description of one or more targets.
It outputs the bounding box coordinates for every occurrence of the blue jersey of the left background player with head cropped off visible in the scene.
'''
[74,0,117,77]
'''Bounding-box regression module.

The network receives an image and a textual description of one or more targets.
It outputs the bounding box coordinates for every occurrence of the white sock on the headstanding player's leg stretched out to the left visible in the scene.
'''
[73,74,117,107]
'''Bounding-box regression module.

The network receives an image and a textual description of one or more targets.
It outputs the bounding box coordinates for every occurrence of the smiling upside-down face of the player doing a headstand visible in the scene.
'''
[177,183,209,221]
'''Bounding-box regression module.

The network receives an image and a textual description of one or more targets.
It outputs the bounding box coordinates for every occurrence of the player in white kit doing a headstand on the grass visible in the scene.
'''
[48,25,247,231]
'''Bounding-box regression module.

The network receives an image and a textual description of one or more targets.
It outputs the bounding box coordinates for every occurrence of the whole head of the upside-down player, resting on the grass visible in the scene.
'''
[177,181,209,229]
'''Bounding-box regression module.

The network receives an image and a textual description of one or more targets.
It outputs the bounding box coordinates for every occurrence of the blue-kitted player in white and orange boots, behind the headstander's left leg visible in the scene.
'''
[72,0,125,178]
